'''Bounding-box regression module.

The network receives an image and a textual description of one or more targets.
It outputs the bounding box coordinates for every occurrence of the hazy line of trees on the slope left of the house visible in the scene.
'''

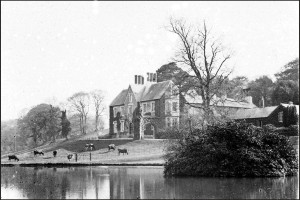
[1,90,105,153]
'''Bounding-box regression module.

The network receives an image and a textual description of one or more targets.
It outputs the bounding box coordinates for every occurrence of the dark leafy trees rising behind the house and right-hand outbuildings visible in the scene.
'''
[157,58,299,107]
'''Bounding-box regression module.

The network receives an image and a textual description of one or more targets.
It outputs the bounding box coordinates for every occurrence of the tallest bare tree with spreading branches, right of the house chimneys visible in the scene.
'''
[167,19,231,122]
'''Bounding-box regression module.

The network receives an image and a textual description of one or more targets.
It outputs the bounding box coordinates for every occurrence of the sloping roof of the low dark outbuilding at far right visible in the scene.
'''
[230,106,278,119]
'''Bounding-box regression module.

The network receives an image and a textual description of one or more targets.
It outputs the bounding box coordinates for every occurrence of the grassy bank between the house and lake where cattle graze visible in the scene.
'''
[1,139,165,165]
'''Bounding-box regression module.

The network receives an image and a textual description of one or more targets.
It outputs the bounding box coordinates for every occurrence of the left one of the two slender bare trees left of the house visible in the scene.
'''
[68,92,90,134]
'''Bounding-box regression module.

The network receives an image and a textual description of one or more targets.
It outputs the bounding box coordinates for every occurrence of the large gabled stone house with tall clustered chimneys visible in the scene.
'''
[109,73,180,139]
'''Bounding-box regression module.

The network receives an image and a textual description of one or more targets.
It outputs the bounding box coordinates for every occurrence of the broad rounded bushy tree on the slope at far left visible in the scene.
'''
[18,104,61,145]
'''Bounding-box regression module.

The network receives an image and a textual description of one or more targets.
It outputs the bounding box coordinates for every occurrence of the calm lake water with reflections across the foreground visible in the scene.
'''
[1,166,299,199]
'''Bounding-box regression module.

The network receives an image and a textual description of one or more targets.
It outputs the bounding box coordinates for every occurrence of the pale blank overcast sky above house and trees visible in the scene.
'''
[1,1,299,123]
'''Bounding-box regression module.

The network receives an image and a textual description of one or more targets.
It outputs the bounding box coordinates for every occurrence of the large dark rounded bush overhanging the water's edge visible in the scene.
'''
[164,122,298,177]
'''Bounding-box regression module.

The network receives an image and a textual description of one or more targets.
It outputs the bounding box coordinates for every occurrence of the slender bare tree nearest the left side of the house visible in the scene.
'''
[90,90,105,132]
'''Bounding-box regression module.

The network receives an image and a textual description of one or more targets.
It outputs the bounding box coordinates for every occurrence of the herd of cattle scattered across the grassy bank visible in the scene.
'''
[8,144,128,161]
